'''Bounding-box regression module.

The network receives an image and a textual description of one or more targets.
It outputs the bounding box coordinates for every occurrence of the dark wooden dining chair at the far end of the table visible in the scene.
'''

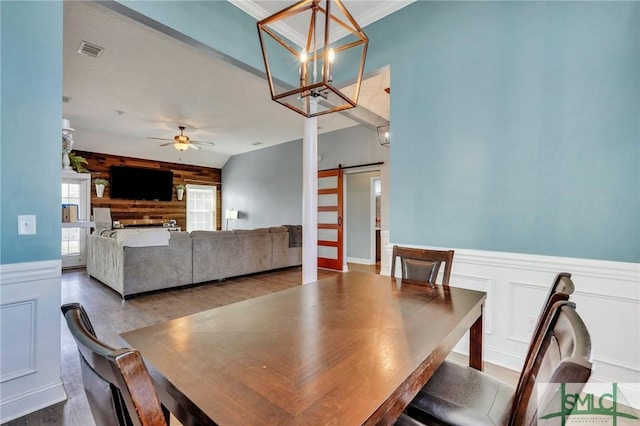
[391,245,455,286]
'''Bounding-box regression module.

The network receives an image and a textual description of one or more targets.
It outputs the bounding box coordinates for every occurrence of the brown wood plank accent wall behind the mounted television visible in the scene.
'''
[74,151,222,231]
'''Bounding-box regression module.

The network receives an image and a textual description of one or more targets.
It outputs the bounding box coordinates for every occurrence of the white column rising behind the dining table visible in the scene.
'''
[302,99,318,284]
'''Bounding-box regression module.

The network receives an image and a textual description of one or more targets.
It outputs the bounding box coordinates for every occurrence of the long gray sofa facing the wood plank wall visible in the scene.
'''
[87,226,302,298]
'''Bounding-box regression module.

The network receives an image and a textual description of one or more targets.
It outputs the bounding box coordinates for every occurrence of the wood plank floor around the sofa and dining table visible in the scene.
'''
[3,264,517,426]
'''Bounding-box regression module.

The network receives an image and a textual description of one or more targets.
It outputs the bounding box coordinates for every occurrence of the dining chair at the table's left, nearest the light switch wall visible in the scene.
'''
[61,303,169,426]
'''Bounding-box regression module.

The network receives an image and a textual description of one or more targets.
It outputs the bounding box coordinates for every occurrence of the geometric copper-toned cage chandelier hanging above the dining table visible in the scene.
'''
[258,0,369,117]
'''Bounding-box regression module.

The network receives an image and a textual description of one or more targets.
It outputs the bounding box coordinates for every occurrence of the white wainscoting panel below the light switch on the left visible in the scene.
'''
[0,260,66,423]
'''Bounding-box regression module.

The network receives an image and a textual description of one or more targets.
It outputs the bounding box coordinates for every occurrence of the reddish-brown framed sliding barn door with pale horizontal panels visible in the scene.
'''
[318,169,344,271]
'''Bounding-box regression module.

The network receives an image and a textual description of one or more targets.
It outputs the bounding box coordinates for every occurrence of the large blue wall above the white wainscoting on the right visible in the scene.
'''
[365,2,640,262]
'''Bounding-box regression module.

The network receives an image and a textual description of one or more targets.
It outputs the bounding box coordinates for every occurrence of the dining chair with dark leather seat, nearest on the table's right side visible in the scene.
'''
[396,300,591,426]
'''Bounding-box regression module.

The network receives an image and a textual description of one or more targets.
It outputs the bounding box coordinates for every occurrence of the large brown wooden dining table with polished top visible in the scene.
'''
[121,271,486,426]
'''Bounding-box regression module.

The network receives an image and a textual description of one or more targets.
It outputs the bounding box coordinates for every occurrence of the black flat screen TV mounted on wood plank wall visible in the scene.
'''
[109,166,173,201]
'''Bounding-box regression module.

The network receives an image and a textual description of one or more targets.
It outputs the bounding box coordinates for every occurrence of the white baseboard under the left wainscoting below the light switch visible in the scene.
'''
[0,382,67,424]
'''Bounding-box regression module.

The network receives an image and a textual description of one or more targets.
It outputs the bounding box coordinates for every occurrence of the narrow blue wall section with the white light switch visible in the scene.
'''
[0,0,62,264]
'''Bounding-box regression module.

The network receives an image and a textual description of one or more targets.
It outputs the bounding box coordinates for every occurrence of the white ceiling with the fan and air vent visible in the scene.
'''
[63,0,409,169]
